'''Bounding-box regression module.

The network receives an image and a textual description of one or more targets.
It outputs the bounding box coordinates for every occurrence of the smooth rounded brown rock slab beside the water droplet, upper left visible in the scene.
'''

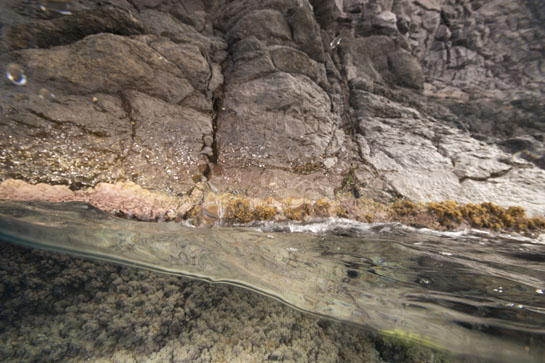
[9,33,192,102]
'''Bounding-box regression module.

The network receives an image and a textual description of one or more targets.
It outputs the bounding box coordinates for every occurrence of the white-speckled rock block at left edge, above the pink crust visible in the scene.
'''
[0,92,131,186]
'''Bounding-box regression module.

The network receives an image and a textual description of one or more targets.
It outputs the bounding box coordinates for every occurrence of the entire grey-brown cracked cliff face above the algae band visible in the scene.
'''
[0,0,545,215]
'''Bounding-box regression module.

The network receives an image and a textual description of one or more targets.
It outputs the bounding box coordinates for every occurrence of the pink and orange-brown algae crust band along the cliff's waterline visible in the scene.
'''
[0,179,545,236]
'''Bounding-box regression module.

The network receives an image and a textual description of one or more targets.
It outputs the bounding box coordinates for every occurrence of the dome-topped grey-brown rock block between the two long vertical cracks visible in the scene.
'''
[213,68,343,200]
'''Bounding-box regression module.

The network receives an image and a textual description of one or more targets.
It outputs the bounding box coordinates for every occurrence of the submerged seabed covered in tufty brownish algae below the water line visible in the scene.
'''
[0,241,450,363]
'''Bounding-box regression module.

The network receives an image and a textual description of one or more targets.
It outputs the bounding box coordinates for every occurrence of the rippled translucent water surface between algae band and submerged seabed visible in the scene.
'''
[0,201,545,362]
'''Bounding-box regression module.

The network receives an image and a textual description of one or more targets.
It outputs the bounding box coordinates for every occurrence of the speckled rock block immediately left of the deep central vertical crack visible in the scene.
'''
[122,92,212,191]
